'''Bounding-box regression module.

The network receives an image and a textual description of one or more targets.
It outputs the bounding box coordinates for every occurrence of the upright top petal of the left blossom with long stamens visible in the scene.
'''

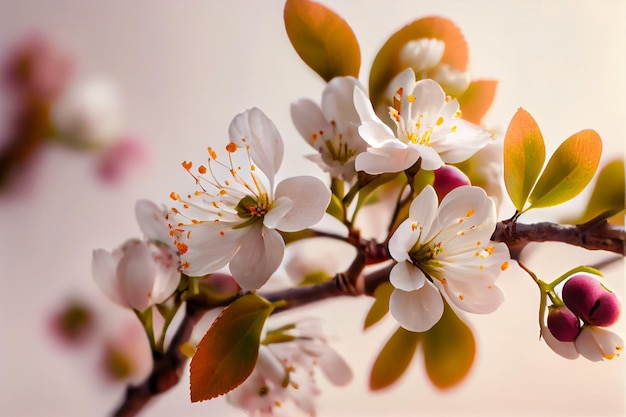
[228,107,284,188]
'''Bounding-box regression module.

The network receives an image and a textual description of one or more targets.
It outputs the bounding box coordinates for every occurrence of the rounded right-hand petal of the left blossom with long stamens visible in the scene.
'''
[268,176,330,232]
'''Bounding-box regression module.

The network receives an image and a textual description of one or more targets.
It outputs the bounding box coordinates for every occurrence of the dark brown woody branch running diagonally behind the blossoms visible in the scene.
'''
[113,221,626,417]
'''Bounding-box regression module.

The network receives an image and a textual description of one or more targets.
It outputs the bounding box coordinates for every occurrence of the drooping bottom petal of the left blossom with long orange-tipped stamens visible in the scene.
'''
[230,226,285,290]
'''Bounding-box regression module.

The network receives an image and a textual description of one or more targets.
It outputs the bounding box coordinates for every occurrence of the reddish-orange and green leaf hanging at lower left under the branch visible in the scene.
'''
[190,294,273,402]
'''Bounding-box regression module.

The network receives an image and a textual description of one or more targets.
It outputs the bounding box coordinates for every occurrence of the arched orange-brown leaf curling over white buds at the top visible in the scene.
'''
[369,16,468,108]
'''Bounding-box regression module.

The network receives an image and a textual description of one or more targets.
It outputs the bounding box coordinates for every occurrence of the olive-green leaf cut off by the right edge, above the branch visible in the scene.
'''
[568,160,626,224]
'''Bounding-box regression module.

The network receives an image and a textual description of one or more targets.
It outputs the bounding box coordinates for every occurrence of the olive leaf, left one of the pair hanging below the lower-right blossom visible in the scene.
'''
[370,327,421,390]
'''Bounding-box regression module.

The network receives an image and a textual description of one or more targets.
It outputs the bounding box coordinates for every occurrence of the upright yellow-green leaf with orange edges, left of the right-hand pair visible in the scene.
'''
[504,108,546,212]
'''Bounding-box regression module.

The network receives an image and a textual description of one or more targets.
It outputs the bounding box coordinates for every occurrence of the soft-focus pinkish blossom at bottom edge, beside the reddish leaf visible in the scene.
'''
[226,319,352,417]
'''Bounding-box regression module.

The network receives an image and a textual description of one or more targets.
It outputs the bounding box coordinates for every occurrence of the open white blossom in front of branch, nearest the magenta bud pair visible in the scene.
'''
[389,186,510,332]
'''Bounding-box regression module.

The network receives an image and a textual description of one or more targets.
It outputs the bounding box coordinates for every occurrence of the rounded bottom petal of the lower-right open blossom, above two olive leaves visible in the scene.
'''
[389,281,443,332]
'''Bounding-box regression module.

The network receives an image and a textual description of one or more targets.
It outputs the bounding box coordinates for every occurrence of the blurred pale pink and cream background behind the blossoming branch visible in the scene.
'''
[0,0,626,417]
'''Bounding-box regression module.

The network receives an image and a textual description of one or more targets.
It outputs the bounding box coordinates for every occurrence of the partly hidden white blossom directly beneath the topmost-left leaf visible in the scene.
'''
[291,77,367,182]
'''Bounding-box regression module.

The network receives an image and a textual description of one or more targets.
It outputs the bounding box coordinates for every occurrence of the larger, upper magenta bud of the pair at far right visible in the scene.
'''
[563,274,621,327]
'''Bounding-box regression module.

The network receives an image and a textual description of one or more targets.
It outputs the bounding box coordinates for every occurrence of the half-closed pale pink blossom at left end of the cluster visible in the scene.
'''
[92,200,180,311]
